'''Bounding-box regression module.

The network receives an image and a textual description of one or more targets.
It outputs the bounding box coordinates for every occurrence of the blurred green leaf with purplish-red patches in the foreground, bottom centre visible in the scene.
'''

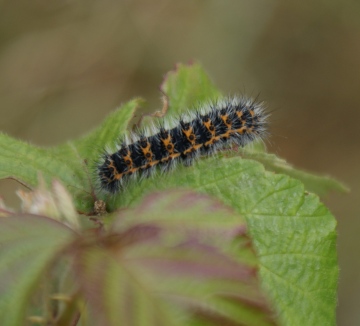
[75,192,273,326]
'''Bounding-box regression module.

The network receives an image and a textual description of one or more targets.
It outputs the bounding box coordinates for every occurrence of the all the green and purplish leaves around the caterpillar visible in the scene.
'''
[0,64,345,325]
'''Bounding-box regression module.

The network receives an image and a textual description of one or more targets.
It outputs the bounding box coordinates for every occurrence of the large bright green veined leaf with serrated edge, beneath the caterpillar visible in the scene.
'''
[111,157,338,325]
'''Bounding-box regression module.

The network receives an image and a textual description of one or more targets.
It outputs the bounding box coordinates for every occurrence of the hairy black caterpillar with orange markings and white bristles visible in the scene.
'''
[97,97,268,193]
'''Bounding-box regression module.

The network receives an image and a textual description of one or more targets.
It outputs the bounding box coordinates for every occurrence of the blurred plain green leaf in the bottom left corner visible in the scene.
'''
[0,215,75,326]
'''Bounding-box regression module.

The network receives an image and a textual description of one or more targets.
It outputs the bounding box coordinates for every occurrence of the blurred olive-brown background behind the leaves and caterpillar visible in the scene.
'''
[0,0,360,325]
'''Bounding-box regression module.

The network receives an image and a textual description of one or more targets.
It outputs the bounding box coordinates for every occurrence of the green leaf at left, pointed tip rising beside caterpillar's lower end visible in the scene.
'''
[0,100,140,213]
